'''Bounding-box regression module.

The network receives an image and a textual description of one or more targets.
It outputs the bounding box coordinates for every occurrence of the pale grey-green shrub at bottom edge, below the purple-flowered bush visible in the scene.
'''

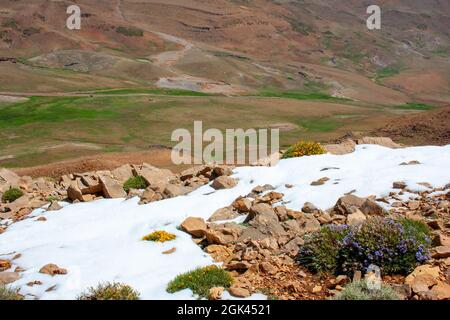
[333,281,400,300]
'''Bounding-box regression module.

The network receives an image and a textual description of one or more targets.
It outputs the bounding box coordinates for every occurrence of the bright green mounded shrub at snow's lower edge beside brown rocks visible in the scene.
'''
[167,265,233,298]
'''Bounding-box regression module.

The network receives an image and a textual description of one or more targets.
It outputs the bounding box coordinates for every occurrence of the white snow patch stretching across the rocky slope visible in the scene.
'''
[0,145,450,299]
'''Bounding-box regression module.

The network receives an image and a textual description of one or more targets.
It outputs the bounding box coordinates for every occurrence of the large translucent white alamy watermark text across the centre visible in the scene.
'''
[171,121,280,165]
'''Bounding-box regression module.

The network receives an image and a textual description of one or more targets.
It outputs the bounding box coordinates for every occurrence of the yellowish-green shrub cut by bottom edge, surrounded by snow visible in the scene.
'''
[77,282,140,300]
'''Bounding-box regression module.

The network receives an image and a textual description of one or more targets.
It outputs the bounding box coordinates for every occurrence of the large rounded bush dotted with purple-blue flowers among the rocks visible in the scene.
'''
[297,217,431,274]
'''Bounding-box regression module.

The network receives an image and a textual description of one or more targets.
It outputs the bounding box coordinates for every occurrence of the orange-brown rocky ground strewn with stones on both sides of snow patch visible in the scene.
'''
[0,137,450,300]
